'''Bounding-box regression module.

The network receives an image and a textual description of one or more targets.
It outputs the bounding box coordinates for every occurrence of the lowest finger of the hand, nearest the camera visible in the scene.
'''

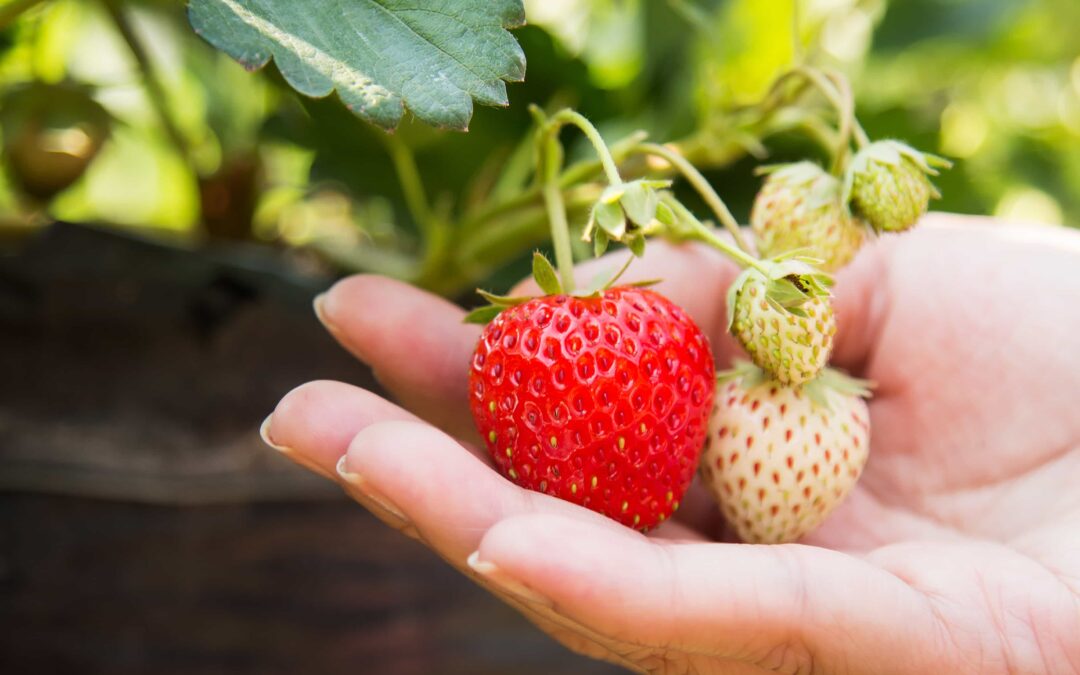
[476,514,941,672]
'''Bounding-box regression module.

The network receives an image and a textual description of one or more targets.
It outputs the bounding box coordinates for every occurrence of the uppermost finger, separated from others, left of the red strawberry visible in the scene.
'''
[315,275,480,440]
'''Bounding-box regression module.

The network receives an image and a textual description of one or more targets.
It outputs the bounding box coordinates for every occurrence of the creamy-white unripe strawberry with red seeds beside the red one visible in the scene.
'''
[701,364,869,543]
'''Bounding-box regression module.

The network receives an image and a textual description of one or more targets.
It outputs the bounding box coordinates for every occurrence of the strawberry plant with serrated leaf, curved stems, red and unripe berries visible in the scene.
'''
[4,0,963,541]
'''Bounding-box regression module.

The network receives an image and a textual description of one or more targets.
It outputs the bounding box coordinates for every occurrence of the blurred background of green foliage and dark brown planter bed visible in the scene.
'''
[0,0,1080,674]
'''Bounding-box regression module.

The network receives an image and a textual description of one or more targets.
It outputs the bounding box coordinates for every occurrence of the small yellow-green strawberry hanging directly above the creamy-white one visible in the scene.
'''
[728,259,836,384]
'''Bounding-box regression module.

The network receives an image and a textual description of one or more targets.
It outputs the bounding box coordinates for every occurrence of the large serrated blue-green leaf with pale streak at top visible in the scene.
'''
[188,0,525,130]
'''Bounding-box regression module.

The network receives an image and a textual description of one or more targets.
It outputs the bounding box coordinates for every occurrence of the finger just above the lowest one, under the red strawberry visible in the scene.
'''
[340,421,639,566]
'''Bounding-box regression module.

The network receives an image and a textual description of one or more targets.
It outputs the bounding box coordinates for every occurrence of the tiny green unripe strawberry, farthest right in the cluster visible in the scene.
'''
[843,140,951,232]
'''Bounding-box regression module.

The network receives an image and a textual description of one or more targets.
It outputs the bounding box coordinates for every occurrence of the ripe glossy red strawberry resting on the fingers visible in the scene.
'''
[469,286,714,530]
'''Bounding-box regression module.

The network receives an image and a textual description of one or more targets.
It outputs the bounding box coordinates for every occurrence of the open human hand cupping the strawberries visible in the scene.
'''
[264,215,1080,674]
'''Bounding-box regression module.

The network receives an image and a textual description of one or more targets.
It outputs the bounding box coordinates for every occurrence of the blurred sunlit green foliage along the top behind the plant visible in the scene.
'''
[0,0,1080,293]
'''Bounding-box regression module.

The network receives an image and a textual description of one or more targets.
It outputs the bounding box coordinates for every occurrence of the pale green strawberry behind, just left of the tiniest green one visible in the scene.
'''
[750,162,866,272]
